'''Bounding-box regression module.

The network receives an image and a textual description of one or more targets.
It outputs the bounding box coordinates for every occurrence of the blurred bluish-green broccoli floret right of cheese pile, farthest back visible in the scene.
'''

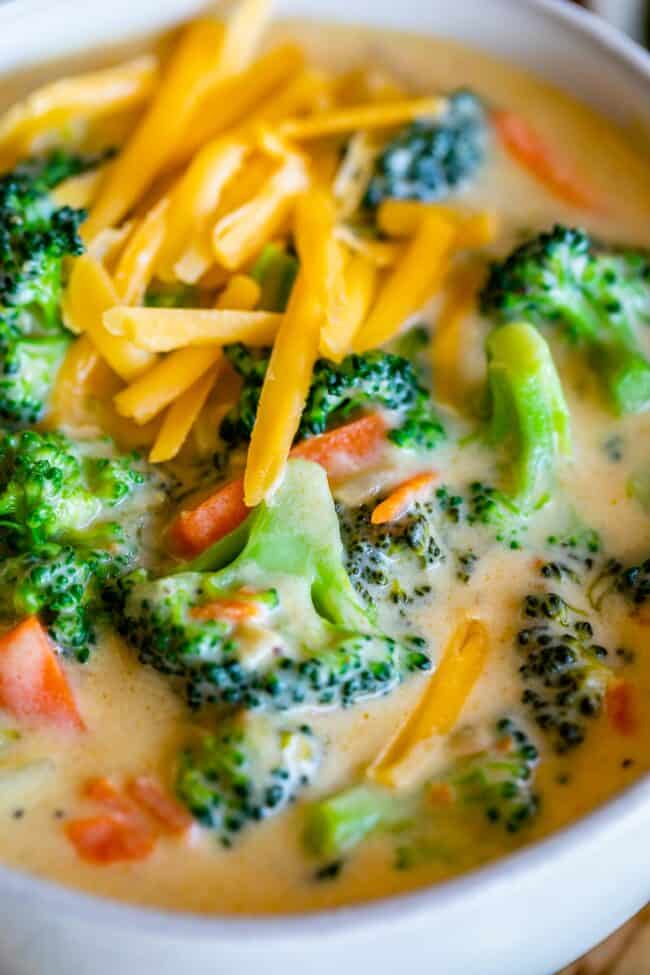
[364,90,488,207]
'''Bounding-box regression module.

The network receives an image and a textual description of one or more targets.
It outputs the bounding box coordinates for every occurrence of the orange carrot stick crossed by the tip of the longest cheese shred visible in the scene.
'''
[170,413,386,557]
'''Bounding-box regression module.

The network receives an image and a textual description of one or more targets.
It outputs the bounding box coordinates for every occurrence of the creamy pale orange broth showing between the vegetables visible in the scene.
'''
[0,17,650,913]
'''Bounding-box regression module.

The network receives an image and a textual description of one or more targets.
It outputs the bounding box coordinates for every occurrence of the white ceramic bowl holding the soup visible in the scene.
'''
[0,0,650,975]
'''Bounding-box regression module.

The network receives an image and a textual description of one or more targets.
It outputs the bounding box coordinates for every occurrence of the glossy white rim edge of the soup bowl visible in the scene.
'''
[0,0,650,943]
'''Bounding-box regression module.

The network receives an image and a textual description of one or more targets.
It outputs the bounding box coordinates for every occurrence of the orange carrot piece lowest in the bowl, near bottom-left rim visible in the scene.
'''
[64,813,155,865]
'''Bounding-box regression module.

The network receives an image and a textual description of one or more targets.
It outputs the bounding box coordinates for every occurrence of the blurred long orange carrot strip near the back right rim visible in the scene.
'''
[492,110,598,210]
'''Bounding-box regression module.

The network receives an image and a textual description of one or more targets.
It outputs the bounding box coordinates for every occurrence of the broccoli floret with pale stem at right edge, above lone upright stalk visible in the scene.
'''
[481,226,650,414]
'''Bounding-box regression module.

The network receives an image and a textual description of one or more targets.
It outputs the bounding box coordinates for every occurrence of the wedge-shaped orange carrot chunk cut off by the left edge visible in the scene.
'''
[0,616,85,731]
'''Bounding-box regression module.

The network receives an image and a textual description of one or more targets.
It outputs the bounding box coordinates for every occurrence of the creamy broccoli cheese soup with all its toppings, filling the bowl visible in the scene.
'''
[0,0,650,913]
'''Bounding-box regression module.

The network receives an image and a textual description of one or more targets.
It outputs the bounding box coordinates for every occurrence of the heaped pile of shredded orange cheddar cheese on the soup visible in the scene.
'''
[0,0,494,505]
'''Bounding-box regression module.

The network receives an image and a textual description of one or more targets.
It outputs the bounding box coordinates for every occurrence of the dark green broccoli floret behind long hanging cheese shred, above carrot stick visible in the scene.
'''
[220,345,445,449]
